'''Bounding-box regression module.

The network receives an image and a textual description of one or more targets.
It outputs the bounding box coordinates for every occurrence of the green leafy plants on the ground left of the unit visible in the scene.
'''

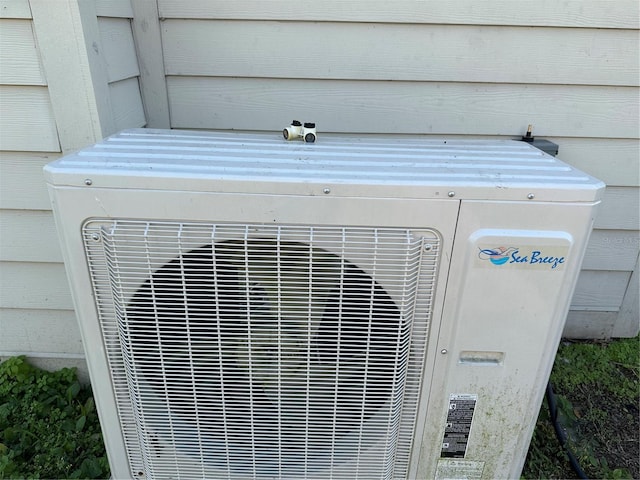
[0,357,109,479]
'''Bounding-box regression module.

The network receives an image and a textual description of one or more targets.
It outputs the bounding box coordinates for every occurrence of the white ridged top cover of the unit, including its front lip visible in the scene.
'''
[45,129,604,202]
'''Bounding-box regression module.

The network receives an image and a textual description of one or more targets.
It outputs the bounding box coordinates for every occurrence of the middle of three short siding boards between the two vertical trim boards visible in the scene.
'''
[98,18,140,82]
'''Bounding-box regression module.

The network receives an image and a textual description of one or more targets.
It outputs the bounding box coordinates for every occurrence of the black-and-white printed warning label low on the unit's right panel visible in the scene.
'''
[440,393,478,458]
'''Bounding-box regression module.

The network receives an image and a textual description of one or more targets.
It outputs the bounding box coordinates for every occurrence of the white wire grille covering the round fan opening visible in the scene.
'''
[84,220,439,479]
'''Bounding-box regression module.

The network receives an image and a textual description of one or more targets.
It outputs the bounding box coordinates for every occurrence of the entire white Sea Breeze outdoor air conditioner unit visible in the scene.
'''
[45,129,604,480]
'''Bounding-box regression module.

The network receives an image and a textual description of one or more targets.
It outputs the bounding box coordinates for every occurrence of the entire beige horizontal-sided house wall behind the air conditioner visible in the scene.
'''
[0,0,640,376]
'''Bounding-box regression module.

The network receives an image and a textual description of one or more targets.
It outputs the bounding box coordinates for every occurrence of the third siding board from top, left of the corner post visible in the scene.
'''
[0,85,60,152]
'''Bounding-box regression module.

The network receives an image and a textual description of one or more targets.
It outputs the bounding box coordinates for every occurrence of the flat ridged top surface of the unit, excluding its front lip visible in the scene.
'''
[45,129,602,201]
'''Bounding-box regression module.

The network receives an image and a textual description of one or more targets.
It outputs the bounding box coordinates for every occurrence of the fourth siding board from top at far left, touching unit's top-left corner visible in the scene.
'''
[0,152,61,210]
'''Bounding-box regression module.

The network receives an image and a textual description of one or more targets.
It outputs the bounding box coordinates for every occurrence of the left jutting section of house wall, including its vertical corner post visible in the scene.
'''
[0,0,146,372]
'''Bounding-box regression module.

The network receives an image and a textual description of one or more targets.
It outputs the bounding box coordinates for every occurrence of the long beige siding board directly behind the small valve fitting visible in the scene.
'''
[167,77,640,138]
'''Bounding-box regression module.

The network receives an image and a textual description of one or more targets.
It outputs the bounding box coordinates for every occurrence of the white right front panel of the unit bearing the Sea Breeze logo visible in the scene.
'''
[410,201,595,478]
